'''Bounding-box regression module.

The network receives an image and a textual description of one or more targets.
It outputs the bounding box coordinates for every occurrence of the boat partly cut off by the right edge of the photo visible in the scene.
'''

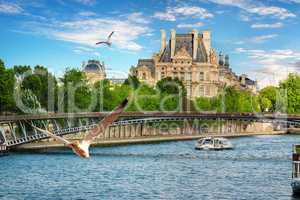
[291,145,300,195]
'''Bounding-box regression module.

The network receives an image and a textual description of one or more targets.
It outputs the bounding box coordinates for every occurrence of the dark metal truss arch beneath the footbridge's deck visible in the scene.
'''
[0,116,300,147]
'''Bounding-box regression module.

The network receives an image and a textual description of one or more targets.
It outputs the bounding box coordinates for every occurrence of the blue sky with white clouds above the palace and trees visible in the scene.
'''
[0,0,300,86]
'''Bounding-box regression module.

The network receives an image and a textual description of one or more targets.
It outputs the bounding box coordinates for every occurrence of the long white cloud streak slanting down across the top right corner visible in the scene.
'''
[208,0,296,19]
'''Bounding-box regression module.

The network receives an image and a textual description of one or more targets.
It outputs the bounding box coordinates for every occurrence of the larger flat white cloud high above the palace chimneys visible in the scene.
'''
[153,6,214,21]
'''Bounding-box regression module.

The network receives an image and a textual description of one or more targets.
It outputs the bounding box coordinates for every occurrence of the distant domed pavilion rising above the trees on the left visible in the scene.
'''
[82,60,106,84]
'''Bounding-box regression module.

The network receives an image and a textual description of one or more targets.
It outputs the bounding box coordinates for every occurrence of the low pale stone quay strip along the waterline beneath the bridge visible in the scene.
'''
[13,131,286,151]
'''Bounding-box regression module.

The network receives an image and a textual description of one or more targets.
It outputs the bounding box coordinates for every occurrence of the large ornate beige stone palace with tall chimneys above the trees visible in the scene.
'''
[131,29,256,98]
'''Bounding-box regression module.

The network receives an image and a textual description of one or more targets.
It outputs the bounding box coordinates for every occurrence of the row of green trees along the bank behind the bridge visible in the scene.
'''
[0,57,300,114]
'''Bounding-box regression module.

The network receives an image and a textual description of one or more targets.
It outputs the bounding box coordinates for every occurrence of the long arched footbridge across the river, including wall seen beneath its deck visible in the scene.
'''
[0,112,300,148]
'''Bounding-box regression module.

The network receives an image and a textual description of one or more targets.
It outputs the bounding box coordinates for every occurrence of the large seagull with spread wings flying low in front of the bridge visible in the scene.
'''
[32,98,128,158]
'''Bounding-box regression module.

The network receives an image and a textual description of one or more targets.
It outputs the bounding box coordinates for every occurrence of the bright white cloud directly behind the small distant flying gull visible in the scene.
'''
[53,18,147,51]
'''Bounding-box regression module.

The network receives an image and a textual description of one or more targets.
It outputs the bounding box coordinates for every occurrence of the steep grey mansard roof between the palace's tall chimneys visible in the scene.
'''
[160,33,207,62]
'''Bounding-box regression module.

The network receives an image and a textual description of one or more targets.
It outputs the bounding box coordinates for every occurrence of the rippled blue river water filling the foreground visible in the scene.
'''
[0,136,300,200]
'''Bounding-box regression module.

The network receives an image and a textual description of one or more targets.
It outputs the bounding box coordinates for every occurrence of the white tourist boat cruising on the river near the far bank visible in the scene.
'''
[195,137,233,150]
